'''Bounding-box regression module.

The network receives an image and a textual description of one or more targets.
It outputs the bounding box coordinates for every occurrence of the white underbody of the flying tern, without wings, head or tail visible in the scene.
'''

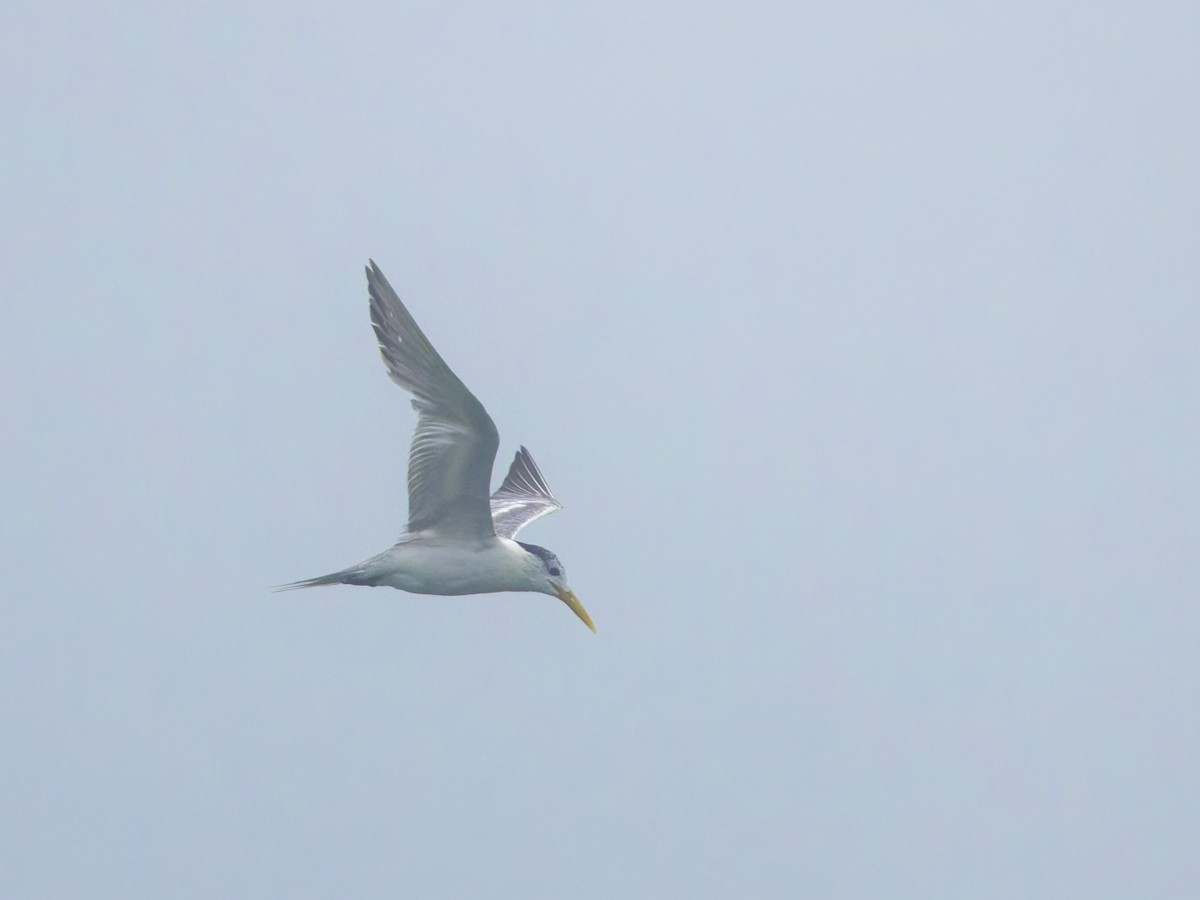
[361,532,552,595]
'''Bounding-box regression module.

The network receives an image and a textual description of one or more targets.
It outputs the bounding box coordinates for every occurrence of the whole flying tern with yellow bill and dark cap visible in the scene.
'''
[278,259,596,631]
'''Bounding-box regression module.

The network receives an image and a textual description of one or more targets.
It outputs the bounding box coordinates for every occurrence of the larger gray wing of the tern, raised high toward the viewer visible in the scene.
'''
[367,260,499,538]
